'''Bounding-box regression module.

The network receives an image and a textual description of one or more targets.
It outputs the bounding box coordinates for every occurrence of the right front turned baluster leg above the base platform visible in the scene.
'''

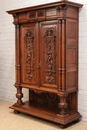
[58,94,68,115]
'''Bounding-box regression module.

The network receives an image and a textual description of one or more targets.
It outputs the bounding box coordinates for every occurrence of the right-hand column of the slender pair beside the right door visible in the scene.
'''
[61,19,65,91]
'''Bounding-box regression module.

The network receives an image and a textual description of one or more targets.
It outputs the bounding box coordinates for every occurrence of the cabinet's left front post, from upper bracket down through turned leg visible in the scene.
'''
[14,15,23,105]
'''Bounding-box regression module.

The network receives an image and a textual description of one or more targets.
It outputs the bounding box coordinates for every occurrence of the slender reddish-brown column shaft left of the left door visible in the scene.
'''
[15,25,20,84]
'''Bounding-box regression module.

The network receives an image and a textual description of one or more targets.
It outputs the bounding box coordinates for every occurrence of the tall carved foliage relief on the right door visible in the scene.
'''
[44,27,56,83]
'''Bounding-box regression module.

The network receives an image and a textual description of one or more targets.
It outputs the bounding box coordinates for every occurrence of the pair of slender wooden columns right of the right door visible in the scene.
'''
[58,19,66,91]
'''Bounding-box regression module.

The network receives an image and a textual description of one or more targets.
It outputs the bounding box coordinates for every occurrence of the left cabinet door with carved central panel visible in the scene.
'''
[20,23,38,85]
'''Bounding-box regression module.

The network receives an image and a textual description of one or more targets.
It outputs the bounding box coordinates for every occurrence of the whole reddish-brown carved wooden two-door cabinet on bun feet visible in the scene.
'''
[7,0,82,125]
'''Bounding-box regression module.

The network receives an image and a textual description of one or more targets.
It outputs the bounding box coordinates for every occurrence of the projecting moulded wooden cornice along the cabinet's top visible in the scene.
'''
[6,0,83,14]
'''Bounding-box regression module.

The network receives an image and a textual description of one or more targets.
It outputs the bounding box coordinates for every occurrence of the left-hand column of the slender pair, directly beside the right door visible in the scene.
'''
[58,20,62,91]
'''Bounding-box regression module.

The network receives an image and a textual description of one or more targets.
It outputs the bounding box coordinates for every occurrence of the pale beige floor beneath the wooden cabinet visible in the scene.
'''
[0,101,87,130]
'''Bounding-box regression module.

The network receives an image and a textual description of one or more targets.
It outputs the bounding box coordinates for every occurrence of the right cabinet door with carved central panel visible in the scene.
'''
[40,21,58,89]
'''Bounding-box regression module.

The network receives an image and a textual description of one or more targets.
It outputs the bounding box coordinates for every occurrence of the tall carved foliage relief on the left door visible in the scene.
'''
[25,30,34,81]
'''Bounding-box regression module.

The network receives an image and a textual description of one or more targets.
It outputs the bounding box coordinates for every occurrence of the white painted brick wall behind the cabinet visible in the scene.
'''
[0,0,87,122]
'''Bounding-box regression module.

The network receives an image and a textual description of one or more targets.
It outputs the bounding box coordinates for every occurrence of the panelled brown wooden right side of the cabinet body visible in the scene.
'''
[66,19,78,91]
